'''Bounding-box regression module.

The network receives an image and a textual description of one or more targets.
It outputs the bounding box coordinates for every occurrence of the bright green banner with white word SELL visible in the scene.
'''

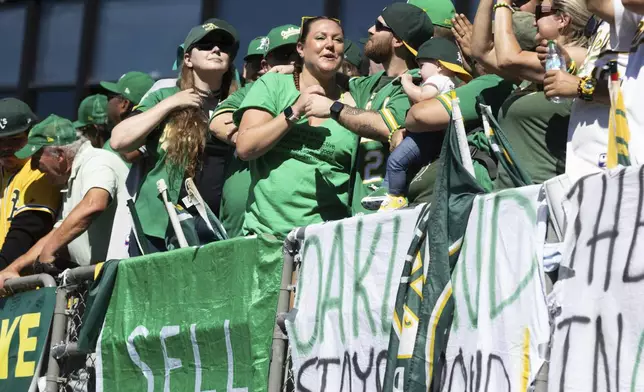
[96,236,283,392]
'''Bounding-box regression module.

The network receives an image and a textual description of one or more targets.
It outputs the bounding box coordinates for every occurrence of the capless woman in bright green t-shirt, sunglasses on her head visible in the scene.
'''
[234,17,356,237]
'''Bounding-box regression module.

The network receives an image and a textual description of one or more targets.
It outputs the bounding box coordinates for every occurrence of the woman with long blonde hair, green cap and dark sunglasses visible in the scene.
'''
[110,19,239,251]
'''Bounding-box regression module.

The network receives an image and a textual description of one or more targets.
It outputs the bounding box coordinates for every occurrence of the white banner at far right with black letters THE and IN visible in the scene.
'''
[548,166,644,392]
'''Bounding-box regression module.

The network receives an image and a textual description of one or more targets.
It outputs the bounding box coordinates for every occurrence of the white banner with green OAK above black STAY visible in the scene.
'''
[287,208,420,392]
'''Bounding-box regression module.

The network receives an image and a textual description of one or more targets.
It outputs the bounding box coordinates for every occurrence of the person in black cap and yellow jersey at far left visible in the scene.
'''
[0,98,60,270]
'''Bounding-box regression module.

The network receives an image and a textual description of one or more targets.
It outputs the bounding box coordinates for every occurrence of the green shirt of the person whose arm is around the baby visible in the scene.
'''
[408,74,515,203]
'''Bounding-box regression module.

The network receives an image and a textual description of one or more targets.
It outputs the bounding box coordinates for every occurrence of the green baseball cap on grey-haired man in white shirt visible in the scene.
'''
[15,114,78,159]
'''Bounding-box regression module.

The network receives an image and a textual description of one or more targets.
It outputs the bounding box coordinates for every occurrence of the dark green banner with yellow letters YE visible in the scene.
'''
[0,287,56,391]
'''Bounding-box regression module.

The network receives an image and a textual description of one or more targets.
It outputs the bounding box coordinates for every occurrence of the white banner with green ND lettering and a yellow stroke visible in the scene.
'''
[442,185,550,392]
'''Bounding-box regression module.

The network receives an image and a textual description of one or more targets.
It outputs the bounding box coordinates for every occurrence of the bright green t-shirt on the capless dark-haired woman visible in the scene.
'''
[234,73,356,238]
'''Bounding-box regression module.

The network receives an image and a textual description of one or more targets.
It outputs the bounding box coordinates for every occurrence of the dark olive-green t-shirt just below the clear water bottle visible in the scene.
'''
[495,90,572,189]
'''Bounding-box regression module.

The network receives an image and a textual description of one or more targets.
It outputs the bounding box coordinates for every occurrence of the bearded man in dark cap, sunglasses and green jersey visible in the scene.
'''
[305,3,434,215]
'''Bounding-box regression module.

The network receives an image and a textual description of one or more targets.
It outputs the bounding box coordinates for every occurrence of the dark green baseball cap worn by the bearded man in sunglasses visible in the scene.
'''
[381,3,434,56]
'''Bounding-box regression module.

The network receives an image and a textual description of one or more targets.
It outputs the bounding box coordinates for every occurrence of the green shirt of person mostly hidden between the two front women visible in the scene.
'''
[210,83,252,238]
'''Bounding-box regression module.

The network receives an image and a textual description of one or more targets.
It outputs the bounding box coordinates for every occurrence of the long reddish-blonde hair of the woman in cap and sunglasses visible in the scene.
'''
[163,61,238,177]
